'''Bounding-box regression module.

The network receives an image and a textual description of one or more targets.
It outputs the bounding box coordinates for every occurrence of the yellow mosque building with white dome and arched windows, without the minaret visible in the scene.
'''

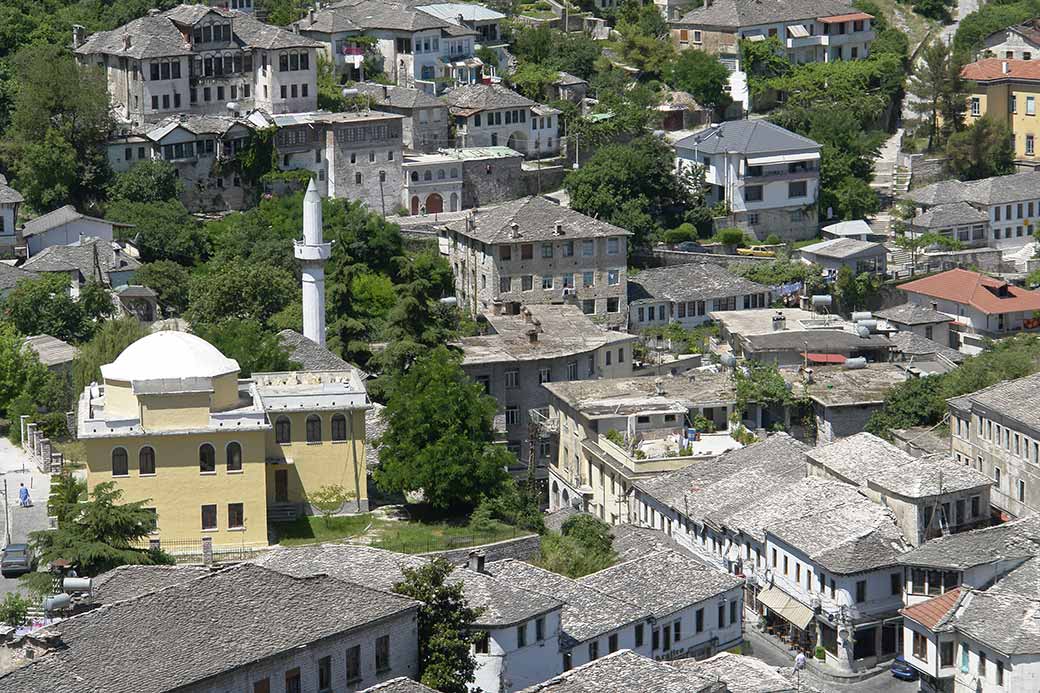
[77,331,371,554]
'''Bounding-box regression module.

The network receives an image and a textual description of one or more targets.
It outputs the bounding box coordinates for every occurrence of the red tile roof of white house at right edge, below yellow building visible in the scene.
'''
[900,270,1040,315]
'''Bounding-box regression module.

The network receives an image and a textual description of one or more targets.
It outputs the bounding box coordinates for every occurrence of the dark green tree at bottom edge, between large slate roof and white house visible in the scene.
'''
[393,559,480,693]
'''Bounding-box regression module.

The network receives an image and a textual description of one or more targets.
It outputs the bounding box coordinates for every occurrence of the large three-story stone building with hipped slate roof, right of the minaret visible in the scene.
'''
[440,195,631,328]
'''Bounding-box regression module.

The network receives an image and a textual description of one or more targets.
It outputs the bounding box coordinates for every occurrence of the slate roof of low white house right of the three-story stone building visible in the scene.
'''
[628,262,770,303]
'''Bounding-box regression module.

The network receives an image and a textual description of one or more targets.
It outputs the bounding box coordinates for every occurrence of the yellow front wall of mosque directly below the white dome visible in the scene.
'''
[84,431,267,550]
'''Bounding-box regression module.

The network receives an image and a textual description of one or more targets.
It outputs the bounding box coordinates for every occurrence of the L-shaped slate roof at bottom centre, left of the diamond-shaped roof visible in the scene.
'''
[488,559,650,649]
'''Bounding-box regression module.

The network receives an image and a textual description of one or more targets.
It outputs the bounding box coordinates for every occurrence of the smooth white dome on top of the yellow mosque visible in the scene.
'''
[101,330,238,382]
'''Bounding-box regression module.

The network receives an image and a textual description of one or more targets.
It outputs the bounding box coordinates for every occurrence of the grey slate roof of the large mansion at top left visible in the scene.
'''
[75,5,321,59]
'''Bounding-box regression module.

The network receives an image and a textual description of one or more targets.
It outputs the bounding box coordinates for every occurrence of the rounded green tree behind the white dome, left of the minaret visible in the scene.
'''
[186,261,300,325]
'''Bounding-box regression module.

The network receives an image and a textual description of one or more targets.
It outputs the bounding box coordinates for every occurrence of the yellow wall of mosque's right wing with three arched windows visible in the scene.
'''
[267,411,368,503]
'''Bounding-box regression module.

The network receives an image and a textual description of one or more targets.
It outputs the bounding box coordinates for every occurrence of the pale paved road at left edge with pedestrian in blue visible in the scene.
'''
[0,438,51,596]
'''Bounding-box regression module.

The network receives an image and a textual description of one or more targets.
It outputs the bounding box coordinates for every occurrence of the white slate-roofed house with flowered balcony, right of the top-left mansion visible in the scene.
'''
[294,0,488,94]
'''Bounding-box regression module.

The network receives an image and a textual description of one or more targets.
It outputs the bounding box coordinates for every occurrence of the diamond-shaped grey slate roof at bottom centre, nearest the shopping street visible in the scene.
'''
[578,550,744,618]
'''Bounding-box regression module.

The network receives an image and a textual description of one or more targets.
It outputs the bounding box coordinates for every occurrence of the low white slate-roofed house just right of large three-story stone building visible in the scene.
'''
[628,262,773,330]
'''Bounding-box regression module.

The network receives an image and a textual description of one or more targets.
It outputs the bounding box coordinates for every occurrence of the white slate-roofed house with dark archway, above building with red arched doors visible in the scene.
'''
[444,84,561,157]
